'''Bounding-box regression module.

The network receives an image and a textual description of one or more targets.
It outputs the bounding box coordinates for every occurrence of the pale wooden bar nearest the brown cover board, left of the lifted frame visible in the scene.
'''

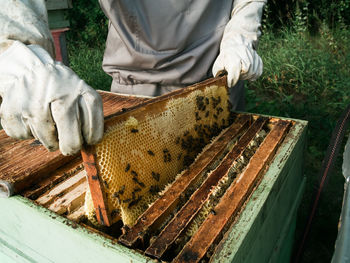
[35,171,86,206]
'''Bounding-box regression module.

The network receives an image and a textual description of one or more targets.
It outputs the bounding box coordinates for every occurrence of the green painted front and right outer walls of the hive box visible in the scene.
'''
[0,118,306,263]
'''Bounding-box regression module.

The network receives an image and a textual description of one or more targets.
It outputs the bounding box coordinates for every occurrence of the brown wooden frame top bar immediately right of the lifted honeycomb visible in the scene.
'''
[120,115,251,249]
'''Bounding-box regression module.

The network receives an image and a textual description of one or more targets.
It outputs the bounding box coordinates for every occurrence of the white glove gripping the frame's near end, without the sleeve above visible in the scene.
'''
[0,41,104,155]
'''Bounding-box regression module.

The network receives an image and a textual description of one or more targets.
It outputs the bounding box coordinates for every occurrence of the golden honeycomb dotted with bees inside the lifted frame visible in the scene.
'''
[95,86,230,226]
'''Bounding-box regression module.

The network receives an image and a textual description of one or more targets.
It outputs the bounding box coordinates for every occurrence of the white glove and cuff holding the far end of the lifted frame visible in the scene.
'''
[213,0,266,87]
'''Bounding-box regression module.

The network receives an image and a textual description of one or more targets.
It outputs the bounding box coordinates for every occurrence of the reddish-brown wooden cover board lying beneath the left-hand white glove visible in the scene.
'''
[0,91,148,196]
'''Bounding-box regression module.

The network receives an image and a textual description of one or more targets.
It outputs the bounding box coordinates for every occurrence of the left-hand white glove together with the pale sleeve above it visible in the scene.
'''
[0,0,103,155]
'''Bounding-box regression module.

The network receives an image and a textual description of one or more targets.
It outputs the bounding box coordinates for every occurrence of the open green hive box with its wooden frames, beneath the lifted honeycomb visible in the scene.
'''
[0,89,306,263]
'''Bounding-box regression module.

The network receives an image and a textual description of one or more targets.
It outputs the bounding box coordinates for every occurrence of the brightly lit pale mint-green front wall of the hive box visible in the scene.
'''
[0,196,152,263]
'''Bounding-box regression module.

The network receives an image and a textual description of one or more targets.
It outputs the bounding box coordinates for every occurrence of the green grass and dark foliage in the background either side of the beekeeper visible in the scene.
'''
[68,0,350,262]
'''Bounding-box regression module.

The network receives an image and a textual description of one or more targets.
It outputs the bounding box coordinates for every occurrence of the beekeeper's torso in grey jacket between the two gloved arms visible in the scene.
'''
[100,0,233,84]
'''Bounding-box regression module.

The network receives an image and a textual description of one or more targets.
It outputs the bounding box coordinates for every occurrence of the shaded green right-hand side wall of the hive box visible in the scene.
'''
[212,121,307,262]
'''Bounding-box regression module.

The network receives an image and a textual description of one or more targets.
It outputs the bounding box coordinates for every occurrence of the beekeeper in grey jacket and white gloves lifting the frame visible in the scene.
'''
[0,0,266,155]
